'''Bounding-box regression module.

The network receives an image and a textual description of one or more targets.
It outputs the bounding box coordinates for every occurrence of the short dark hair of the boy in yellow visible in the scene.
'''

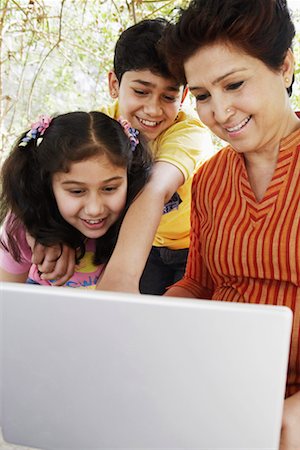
[114,18,172,83]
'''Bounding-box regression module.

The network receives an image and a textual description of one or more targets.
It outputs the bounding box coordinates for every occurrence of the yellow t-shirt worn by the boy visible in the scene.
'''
[101,101,214,250]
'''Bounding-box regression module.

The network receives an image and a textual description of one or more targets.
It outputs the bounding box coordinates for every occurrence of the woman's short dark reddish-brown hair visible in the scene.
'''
[163,0,295,95]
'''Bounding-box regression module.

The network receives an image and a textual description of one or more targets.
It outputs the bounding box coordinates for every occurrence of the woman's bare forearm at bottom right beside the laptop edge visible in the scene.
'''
[280,392,300,450]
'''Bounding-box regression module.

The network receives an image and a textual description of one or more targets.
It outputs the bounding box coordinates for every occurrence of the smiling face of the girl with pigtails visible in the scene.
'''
[52,154,127,239]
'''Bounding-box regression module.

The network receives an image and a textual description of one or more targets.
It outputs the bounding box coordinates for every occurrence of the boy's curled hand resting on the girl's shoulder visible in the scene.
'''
[26,234,75,286]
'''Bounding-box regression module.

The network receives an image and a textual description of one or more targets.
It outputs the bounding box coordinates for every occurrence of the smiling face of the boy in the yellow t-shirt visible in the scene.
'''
[108,69,183,140]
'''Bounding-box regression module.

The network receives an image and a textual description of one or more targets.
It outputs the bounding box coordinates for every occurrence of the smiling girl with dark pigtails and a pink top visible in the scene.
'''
[0,112,151,287]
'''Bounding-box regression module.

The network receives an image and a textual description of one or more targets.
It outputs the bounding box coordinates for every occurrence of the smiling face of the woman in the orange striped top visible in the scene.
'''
[184,43,297,153]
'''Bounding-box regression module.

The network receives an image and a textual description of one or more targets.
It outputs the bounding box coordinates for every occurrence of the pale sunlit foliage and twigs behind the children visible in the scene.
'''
[0,0,186,160]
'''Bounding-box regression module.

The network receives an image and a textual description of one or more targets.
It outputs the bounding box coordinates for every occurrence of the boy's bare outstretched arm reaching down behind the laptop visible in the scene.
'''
[97,161,184,292]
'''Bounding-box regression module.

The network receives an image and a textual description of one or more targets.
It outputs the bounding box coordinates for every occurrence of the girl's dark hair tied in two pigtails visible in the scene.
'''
[0,111,152,264]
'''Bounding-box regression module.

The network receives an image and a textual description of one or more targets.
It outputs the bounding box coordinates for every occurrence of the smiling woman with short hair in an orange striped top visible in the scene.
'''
[165,0,300,450]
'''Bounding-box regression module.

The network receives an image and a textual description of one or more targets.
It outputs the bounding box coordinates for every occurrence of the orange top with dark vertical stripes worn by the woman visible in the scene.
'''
[176,125,300,395]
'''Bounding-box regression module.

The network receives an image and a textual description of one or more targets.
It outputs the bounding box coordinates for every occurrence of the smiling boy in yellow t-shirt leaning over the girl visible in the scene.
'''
[30,19,213,295]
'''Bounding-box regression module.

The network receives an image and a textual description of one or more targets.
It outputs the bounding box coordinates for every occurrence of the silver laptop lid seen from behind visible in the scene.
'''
[1,283,292,450]
